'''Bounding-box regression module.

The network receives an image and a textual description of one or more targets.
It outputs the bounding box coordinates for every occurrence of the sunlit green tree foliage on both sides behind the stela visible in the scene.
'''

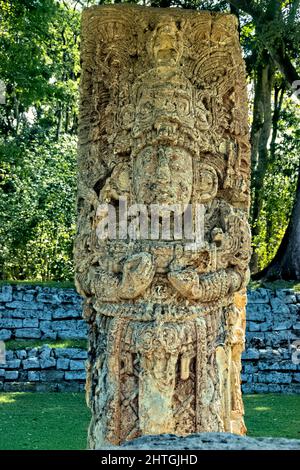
[0,0,300,281]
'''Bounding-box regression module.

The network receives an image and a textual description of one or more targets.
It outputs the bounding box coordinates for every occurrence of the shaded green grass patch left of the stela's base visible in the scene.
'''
[0,393,90,450]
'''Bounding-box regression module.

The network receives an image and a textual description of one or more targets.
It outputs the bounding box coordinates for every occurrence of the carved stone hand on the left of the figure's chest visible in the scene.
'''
[119,253,155,299]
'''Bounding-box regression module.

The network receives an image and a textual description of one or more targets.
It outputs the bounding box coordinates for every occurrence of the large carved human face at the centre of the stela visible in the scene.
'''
[133,147,193,207]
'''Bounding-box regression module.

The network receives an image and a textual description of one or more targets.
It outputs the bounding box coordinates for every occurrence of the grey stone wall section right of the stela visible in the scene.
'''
[242,289,300,393]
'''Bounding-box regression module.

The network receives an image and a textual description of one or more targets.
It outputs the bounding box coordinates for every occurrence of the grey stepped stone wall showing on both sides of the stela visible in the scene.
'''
[0,286,300,393]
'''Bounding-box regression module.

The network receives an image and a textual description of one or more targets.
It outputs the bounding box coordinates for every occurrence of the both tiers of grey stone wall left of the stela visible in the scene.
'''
[0,285,87,392]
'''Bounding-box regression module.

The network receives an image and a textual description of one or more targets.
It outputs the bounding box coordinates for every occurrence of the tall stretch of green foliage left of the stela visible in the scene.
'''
[0,0,80,281]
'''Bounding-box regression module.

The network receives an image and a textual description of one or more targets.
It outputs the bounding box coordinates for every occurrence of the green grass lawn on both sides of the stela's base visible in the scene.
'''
[0,393,300,450]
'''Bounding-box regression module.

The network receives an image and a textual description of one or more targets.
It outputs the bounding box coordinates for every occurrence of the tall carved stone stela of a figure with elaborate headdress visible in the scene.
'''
[75,5,250,448]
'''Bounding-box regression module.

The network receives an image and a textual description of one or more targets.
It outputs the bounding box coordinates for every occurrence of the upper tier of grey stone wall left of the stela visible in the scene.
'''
[0,285,87,341]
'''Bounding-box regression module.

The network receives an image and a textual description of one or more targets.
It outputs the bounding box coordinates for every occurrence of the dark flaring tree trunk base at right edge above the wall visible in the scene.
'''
[253,165,300,281]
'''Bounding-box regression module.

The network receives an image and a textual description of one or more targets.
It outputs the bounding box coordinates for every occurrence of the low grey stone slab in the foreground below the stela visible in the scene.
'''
[99,433,300,451]
